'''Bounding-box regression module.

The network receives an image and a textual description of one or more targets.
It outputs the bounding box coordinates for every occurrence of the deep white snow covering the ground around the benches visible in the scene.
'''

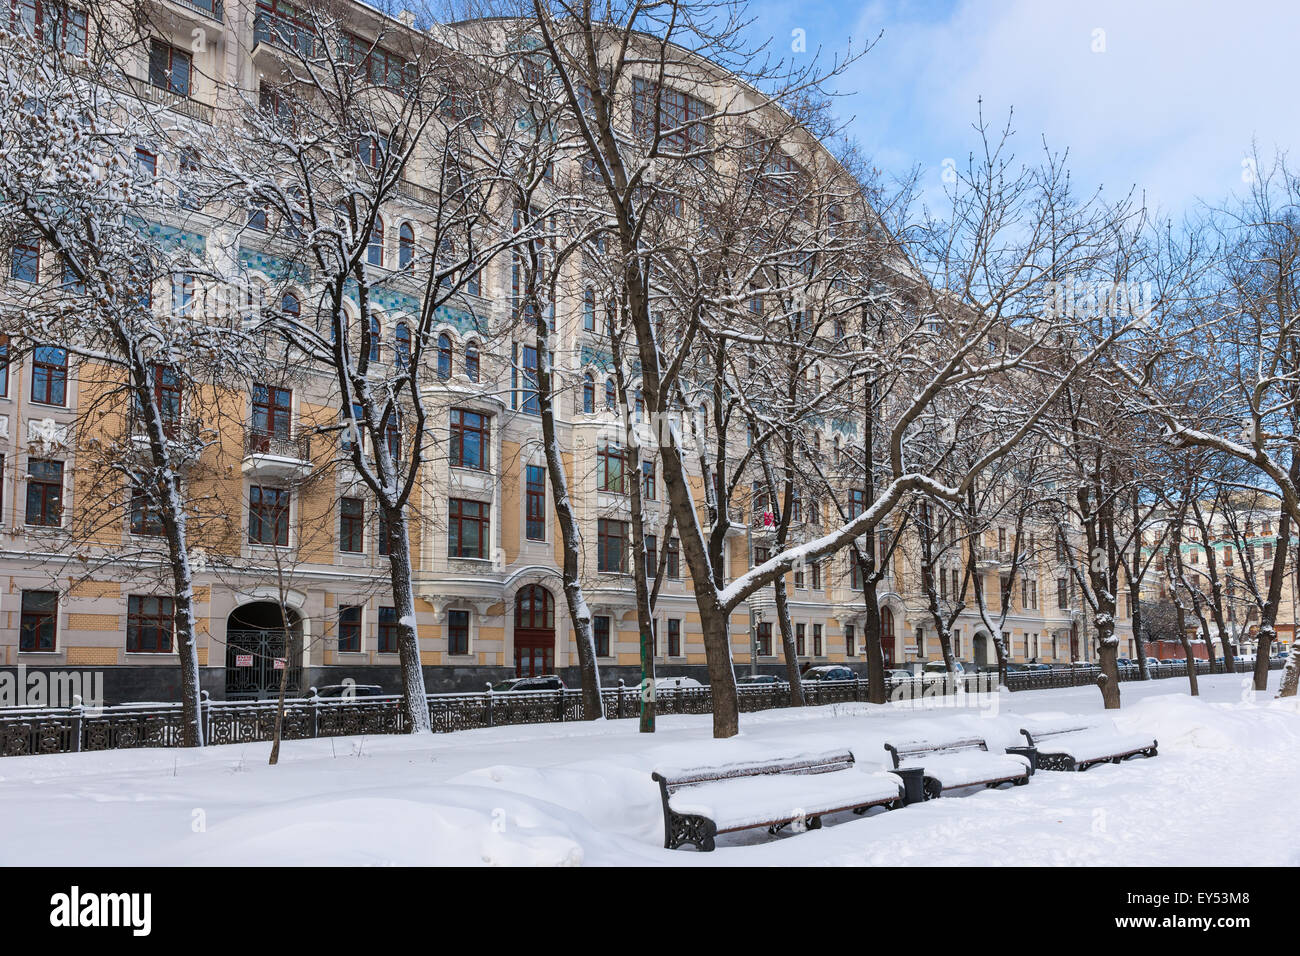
[0,672,1300,866]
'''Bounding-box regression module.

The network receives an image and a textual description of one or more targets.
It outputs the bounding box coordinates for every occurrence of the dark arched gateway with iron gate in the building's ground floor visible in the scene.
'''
[226,601,303,700]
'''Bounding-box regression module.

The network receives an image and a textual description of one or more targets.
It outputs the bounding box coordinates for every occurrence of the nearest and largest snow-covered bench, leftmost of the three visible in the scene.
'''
[651,750,902,851]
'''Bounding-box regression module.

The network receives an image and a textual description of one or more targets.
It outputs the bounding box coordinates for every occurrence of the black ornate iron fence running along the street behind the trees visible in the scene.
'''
[0,661,1282,757]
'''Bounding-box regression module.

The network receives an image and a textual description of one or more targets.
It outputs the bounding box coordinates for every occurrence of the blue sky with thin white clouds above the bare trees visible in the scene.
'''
[750,0,1300,216]
